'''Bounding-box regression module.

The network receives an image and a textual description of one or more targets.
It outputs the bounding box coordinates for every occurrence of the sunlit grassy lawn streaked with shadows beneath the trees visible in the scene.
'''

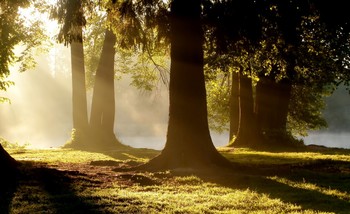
[0,148,350,214]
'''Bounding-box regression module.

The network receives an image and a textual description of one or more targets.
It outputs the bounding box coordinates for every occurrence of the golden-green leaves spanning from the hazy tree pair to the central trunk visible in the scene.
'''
[58,0,169,91]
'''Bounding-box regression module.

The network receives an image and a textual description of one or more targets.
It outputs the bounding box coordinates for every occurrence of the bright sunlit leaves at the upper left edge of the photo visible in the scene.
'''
[0,0,47,102]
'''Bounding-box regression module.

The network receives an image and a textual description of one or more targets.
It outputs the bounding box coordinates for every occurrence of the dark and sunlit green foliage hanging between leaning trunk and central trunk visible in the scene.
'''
[110,0,170,91]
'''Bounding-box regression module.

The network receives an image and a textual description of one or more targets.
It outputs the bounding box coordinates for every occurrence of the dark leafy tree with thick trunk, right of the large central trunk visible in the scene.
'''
[205,1,346,149]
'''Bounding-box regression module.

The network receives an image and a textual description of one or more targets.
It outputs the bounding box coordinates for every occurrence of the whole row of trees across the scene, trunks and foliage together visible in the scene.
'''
[0,0,349,176]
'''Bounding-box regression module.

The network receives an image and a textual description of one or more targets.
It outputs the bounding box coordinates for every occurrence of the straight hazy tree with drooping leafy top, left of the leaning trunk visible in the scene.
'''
[52,0,89,144]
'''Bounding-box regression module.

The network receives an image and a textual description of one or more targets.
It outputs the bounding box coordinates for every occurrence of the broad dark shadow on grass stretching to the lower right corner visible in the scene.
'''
[196,166,350,213]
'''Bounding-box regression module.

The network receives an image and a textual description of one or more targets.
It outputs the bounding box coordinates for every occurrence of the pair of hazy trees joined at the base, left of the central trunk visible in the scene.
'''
[53,1,126,150]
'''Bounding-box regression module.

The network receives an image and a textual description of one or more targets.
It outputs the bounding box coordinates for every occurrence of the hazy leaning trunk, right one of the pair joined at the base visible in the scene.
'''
[90,30,121,148]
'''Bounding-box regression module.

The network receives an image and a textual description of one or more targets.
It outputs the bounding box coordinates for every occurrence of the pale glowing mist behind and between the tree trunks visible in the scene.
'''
[0,45,350,150]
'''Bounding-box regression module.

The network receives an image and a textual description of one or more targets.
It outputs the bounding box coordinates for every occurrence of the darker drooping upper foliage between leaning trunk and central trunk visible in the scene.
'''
[112,0,169,51]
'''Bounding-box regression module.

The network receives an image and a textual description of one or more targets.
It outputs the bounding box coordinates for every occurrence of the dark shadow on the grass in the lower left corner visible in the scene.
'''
[4,162,106,213]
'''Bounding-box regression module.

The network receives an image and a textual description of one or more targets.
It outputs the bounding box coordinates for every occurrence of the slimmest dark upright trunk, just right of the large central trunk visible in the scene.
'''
[229,72,239,143]
